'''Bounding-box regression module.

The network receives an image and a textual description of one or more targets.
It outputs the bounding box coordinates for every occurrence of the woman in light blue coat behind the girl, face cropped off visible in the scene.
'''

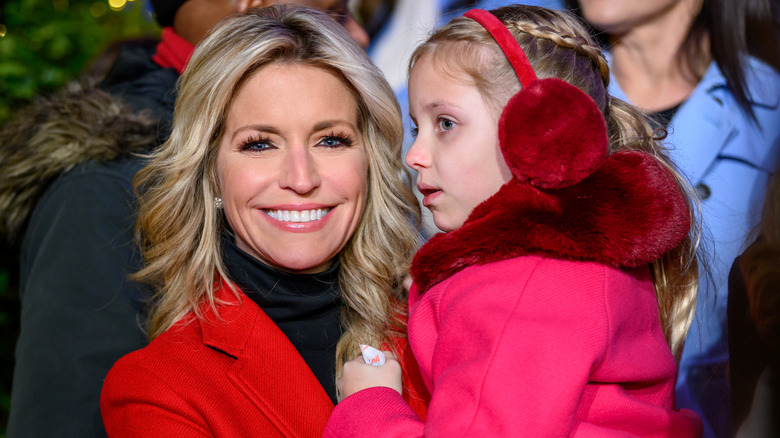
[568,0,780,437]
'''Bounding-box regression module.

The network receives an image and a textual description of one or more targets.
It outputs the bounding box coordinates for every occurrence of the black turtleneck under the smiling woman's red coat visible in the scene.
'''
[222,235,341,404]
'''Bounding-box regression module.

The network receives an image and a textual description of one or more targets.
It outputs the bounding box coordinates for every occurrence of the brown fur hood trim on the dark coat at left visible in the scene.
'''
[0,78,157,242]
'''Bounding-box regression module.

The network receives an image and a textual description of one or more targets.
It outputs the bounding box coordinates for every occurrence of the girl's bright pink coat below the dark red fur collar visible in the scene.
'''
[325,255,701,437]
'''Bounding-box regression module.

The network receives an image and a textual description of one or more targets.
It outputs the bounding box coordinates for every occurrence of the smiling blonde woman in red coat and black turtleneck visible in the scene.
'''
[101,7,430,436]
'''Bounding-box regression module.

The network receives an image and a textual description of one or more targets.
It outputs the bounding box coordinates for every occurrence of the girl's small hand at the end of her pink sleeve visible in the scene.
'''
[337,351,402,400]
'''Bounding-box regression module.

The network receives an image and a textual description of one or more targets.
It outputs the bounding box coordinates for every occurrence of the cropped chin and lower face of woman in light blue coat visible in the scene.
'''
[579,0,699,35]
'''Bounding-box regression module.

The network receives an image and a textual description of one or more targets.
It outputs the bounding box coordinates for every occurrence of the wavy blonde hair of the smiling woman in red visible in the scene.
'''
[135,6,420,369]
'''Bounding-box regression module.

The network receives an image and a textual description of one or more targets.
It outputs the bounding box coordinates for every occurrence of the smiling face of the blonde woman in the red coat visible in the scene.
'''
[217,64,368,273]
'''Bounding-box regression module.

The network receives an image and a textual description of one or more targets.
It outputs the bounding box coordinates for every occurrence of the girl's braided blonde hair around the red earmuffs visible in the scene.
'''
[409,5,701,359]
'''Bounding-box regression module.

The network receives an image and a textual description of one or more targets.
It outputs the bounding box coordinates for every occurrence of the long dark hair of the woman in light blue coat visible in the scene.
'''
[564,0,780,120]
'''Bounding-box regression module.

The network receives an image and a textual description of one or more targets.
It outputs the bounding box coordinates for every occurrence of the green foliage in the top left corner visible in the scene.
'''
[0,0,159,125]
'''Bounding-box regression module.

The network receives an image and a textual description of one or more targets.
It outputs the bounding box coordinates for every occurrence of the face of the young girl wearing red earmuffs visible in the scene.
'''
[406,56,512,231]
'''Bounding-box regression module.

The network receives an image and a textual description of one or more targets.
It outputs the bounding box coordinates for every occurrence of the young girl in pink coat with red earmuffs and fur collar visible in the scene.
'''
[325,6,701,436]
